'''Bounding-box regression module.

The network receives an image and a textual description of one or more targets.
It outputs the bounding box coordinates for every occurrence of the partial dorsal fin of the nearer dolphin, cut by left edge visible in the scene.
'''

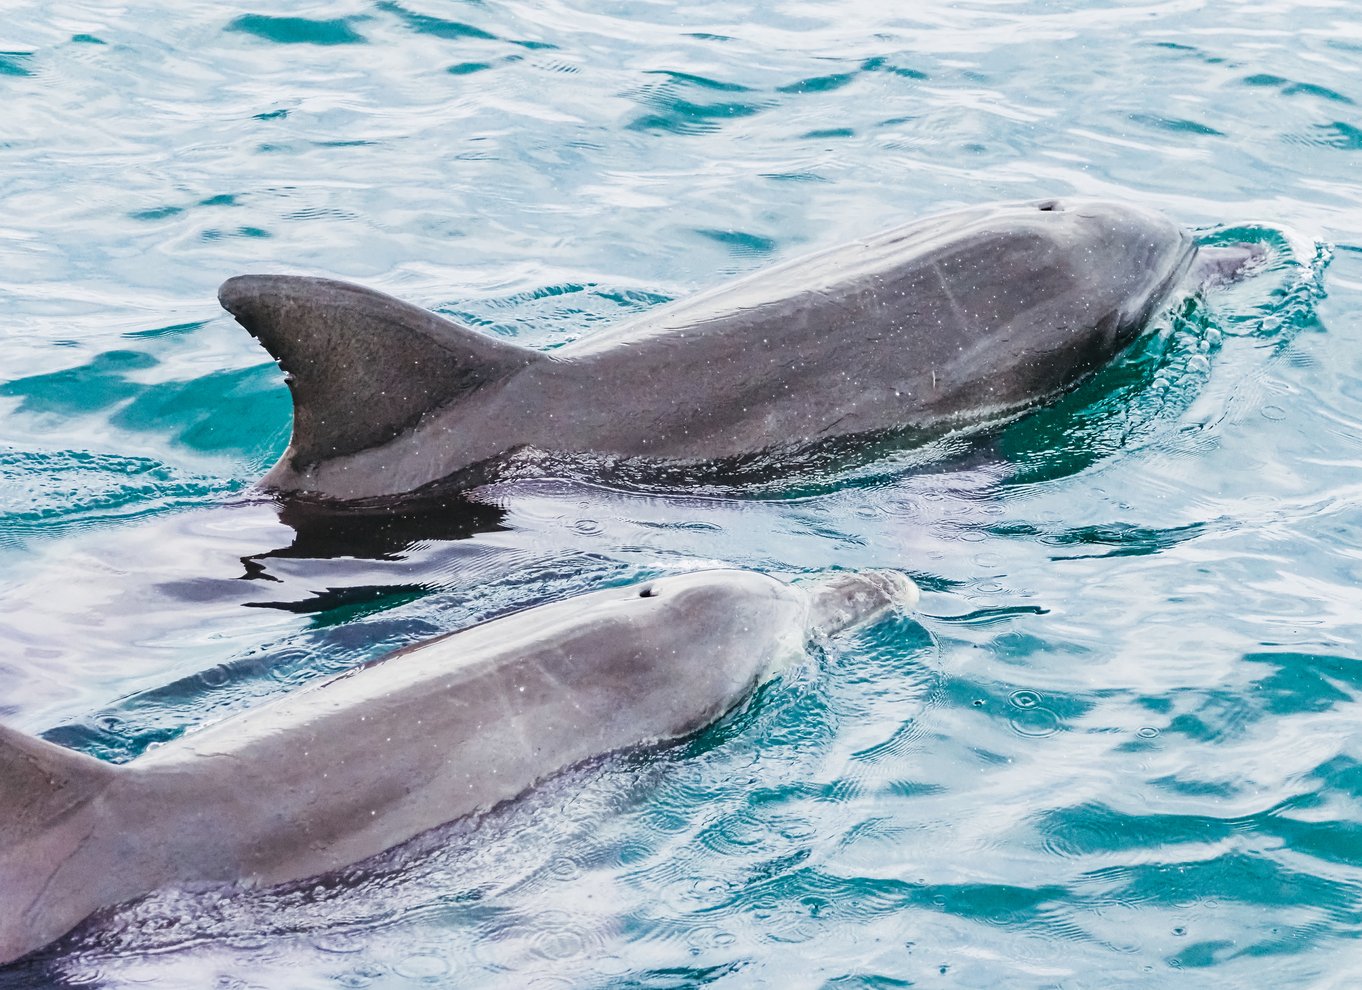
[0,726,118,850]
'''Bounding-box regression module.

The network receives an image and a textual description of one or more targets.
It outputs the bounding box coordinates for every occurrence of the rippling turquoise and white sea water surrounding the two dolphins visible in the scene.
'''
[0,0,1362,990]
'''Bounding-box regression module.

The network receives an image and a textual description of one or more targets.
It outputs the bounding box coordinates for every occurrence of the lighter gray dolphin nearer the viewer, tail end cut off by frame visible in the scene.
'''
[0,571,918,964]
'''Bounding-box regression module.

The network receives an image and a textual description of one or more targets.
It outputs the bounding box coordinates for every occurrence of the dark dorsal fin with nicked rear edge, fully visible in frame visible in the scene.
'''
[218,275,541,467]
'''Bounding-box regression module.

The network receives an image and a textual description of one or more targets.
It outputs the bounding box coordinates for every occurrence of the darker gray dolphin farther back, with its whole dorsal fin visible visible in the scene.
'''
[218,200,1256,500]
